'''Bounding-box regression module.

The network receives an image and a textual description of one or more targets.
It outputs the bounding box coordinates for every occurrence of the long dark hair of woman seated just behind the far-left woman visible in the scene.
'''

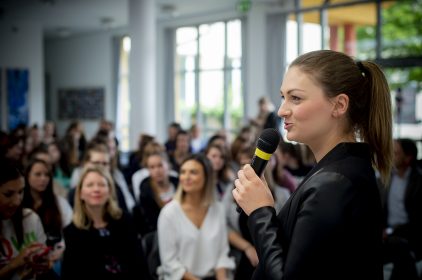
[23,159,63,235]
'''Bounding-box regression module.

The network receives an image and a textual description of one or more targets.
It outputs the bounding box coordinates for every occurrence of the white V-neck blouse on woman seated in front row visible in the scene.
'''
[157,200,235,280]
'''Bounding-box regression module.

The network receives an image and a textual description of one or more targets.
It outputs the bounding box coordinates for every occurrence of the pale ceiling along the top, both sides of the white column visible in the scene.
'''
[0,0,239,37]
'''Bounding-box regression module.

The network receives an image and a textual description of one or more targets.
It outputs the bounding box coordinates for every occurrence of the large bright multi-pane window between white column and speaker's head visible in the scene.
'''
[174,20,243,137]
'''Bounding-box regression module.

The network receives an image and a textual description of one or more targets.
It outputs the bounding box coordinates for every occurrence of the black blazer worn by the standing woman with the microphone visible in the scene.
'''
[248,143,383,280]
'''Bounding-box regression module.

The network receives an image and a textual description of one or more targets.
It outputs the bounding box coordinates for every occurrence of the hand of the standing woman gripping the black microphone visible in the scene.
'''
[232,164,274,216]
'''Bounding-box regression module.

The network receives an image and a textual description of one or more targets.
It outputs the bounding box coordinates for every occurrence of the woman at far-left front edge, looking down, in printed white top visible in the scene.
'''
[0,161,49,280]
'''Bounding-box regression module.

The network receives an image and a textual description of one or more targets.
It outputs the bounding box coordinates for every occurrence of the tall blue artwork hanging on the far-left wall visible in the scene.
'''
[6,69,29,130]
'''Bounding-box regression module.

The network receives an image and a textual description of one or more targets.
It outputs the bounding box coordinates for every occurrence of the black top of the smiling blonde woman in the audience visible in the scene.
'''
[62,214,143,280]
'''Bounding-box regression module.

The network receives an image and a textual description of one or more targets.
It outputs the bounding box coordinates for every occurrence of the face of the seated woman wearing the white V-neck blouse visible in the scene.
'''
[179,160,205,193]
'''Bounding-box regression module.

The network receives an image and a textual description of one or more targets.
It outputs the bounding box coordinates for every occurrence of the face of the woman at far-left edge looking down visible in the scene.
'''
[0,177,25,219]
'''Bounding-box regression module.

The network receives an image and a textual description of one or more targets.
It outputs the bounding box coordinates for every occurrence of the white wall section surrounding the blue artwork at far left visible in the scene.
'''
[0,22,45,129]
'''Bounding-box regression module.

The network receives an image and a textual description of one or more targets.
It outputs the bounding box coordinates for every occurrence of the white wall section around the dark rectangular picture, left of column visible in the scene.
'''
[45,32,116,139]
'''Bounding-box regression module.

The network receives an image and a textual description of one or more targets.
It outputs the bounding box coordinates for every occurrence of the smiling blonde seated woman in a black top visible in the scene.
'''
[62,165,142,280]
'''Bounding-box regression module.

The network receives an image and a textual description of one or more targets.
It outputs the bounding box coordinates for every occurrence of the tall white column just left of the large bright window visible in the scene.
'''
[129,0,157,149]
